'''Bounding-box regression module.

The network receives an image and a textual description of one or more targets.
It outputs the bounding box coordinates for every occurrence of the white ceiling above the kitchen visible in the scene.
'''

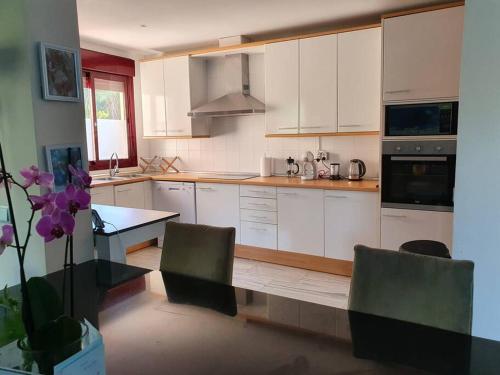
[77,0,454,54]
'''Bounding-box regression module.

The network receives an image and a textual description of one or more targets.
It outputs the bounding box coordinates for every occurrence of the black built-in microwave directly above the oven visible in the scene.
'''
[384,102,458,137]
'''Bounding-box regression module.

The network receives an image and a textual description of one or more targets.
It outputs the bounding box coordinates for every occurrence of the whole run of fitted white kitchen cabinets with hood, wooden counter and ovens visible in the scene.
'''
[87,3,463,276]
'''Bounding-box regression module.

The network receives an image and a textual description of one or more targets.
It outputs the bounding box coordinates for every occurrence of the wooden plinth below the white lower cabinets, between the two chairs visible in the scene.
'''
[234,245,352,276]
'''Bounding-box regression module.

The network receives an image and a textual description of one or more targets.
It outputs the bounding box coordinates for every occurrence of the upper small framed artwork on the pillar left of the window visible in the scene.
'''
[40,42,81,102]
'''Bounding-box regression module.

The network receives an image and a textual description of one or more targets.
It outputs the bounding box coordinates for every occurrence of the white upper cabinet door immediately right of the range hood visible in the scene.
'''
[265,40,299,134]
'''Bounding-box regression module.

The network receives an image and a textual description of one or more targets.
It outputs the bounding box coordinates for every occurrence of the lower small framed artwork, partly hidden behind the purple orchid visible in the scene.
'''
[45,145,83,192]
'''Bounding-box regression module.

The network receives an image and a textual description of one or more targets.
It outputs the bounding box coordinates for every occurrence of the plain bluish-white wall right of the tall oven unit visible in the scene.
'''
[453,0,500,340]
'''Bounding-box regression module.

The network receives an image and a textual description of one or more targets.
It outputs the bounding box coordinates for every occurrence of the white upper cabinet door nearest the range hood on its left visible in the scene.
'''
[164,56,191,137]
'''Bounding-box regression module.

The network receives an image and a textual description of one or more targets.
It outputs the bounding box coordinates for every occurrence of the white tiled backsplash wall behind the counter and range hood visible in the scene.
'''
[149,54,379,177]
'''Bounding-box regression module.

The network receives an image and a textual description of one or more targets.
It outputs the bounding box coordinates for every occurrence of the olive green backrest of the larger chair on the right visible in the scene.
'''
[349,245,474,334]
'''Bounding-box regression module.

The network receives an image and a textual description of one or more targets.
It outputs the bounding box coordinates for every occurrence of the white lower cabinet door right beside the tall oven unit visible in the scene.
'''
[324,190,380,261]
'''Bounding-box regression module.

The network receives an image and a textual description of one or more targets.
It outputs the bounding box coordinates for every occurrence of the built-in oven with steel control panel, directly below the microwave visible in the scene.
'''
[381,140,456,211]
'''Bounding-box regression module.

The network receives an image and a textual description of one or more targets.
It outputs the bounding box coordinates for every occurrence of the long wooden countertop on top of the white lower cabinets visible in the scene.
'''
[92,173,379,192]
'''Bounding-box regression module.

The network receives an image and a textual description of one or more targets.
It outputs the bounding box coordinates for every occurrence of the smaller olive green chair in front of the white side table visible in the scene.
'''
[160,222,236,285]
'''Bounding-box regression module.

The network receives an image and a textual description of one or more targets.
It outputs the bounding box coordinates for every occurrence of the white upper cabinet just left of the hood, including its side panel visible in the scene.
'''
[163,56,208,137]
